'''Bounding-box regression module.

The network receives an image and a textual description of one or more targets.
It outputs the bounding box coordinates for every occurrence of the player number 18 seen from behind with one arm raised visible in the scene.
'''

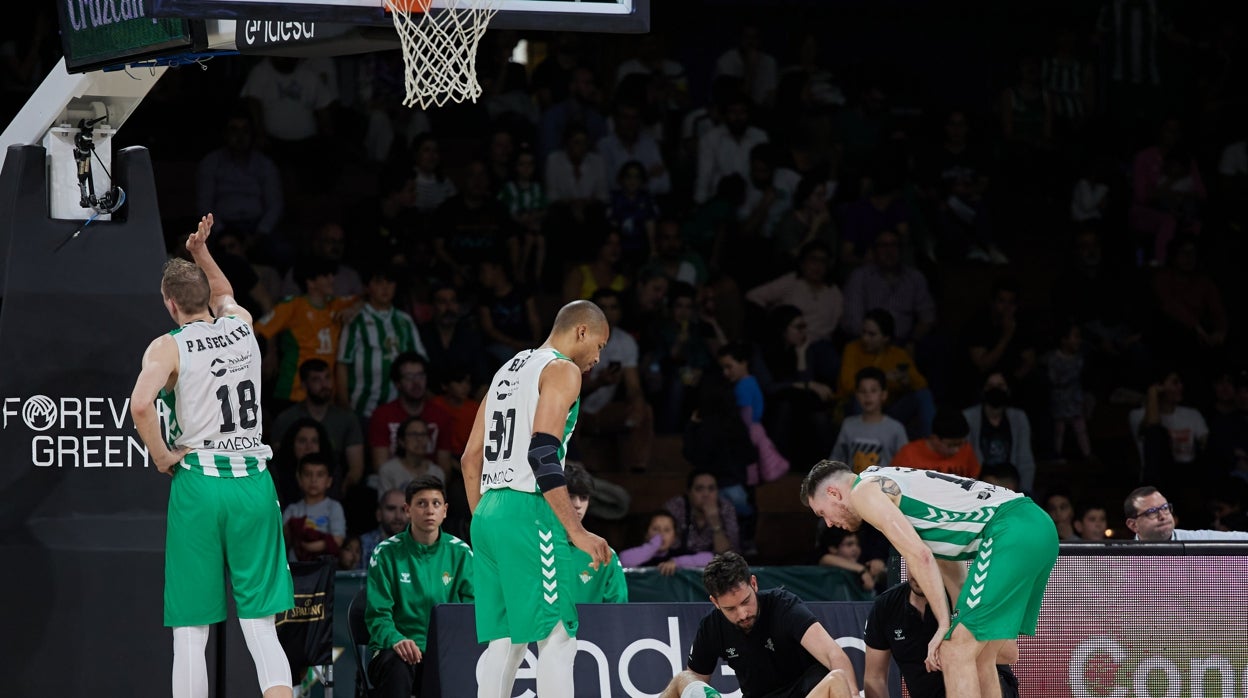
[130,214,295,698]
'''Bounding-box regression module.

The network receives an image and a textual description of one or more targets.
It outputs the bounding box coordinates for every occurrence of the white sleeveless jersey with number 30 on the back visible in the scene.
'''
[480,347,580,494]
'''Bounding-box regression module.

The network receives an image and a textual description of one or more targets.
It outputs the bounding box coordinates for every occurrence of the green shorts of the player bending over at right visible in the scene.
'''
[946,497,1057,642]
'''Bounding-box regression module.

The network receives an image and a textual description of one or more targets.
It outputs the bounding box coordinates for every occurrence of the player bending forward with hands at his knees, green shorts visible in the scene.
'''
[801,461,1057,698]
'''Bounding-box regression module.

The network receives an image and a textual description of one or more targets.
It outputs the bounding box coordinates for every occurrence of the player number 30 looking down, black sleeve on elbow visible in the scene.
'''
[462,301,612,698]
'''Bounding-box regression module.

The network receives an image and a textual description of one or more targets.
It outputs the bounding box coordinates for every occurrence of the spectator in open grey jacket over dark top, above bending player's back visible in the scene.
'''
[962,371,1036,492]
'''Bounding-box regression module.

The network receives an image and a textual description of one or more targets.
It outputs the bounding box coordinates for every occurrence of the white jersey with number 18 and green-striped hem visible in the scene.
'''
[161,315,273,477]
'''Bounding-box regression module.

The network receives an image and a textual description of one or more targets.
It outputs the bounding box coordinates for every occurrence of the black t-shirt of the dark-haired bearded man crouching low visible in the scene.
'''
[689,589,819,698]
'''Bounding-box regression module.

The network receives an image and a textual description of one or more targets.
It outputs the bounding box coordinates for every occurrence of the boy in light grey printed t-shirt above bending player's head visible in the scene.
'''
[831,366,907,472]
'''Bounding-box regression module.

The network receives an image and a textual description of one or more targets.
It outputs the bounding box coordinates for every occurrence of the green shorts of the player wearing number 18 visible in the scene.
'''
[165,468,295,627]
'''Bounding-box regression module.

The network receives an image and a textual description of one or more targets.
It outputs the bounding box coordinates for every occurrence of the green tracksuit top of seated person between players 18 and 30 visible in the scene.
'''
[364,526,473,654]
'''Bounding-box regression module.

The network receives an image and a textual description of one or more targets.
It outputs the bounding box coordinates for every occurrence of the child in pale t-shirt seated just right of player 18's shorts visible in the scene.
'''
[282,453,347,562]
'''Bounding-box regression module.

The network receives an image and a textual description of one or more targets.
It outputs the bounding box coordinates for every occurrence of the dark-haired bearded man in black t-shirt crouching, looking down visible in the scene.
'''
[663,552,859,698]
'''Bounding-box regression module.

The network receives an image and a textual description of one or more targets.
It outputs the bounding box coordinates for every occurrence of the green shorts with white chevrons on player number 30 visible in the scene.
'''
[472,489,577,643]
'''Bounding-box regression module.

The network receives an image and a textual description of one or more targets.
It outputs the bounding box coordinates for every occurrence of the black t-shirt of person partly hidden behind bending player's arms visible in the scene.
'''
[862,582,945,698]
